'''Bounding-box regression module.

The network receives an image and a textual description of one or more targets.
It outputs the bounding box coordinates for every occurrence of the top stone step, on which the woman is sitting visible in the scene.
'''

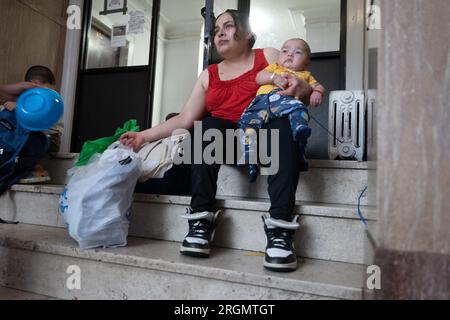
[39,153,375,206]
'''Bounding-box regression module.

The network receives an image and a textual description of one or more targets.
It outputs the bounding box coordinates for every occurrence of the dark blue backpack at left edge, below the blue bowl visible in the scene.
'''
[0,109,30,195]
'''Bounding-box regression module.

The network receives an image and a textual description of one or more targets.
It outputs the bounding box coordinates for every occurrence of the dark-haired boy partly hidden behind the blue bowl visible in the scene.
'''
[4,66,63,183]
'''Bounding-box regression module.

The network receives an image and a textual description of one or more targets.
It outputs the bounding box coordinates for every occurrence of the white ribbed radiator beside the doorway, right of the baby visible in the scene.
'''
[328,90,366,161]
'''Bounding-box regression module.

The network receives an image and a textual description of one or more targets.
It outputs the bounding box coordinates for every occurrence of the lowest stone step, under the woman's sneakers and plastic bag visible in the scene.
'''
[0,224,365,300]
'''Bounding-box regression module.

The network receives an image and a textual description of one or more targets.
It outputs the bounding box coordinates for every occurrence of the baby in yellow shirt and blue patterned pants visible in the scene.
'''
[239,39,325,182]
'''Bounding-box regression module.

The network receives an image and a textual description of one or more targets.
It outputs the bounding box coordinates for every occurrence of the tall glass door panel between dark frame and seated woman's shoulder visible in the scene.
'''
[152,0,205,126]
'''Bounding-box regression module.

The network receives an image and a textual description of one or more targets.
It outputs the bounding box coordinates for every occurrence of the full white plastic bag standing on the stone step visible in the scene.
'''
[60,143,141,249]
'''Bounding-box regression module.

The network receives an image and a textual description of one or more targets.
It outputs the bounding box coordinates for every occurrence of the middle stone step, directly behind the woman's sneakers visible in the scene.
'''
[0,185,375,264]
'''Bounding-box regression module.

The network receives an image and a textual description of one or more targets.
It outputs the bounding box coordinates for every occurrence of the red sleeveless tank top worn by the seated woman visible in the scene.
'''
[206,49,269,122]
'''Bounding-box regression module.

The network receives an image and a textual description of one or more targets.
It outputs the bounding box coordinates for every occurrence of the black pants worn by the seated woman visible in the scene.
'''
[191,117,304,221]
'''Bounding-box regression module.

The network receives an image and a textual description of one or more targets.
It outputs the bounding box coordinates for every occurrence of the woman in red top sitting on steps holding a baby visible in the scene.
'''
[120,10,312,271]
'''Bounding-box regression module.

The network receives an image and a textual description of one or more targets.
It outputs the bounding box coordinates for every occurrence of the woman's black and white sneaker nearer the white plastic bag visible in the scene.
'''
[180,209,221,258]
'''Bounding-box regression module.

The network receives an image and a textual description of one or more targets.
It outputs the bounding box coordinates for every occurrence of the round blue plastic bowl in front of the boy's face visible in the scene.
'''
[16,88,64,131]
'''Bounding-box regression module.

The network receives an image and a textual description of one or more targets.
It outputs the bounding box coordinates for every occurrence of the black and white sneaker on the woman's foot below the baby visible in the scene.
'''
[262,215,300,272]
